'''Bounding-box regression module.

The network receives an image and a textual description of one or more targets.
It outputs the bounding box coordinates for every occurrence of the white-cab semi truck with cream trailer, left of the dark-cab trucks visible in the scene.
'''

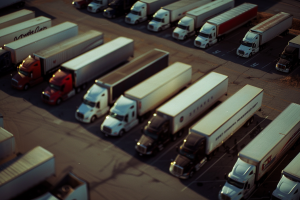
[100,62,192,136]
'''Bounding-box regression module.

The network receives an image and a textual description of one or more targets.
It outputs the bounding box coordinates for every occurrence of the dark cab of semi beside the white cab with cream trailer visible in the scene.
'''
[135,114,177,155]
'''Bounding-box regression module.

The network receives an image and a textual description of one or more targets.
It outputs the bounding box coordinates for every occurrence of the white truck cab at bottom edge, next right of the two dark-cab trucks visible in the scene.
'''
[219,158,256,200]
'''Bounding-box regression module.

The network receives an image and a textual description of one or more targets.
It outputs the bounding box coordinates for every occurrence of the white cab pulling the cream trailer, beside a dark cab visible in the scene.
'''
[101,95,139,136]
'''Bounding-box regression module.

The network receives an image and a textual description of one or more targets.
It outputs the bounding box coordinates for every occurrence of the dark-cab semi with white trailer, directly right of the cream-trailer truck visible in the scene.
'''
[135,72,228,155]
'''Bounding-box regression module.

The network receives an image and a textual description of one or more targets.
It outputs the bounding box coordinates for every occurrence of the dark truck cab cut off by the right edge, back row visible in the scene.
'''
[276,46,299,73]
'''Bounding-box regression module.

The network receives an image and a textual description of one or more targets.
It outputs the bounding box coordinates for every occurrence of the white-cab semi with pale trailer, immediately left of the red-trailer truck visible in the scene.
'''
[172,0,234,40]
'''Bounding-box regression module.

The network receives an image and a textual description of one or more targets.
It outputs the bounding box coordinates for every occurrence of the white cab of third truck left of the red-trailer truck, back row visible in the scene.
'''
[125,1,147,24]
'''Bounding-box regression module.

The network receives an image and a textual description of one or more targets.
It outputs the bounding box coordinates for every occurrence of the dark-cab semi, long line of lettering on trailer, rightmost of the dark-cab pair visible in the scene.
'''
[169,85,263,179]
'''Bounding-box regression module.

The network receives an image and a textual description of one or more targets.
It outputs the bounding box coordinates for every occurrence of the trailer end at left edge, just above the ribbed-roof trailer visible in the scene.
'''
[0,127,16,160]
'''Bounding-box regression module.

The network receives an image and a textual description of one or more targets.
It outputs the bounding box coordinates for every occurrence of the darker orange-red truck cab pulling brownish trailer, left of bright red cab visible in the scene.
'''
[11,55,43,90]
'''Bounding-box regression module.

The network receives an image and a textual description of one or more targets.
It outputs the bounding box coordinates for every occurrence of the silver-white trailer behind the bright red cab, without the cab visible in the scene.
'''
[61,37,134,87]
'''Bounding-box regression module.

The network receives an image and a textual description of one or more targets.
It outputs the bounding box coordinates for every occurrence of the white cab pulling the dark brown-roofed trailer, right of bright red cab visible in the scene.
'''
[75,84,109,123]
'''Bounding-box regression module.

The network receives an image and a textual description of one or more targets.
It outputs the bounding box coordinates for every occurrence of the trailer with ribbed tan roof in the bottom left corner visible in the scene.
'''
[0,146,55,200]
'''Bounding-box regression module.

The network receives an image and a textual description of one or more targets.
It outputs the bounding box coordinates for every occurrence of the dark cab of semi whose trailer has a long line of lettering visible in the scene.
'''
[169,133,207,179]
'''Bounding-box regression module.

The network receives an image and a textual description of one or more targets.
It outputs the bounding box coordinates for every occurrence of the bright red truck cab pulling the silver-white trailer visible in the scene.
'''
[42,69,75,105]
